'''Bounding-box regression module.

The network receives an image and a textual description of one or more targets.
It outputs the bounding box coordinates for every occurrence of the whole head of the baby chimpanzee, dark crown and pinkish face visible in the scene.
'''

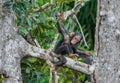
[70,33,83,45]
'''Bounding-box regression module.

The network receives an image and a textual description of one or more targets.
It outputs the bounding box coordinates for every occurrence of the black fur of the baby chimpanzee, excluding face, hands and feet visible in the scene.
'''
[54,21,92,82]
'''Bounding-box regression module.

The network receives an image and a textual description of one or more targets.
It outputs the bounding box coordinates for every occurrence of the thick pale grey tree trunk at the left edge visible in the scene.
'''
[0,15,26,83]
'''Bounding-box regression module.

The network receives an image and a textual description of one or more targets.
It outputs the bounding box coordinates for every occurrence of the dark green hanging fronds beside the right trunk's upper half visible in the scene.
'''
[76,0,97,50]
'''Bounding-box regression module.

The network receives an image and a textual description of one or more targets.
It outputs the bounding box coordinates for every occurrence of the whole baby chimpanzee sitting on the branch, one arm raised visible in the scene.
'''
[54,21,92,82]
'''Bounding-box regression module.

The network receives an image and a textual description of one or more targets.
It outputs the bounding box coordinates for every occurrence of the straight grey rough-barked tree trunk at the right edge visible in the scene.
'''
[94,0,120,83]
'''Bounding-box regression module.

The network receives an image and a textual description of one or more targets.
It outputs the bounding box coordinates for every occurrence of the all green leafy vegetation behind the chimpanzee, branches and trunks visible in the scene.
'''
[3,0,97,83]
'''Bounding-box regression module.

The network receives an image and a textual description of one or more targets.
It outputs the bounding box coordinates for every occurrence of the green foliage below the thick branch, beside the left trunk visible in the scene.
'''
[21,57,49,83]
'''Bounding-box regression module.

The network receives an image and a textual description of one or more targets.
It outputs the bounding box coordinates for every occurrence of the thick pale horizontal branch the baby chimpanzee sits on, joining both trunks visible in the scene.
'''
[25,44,95,74]
